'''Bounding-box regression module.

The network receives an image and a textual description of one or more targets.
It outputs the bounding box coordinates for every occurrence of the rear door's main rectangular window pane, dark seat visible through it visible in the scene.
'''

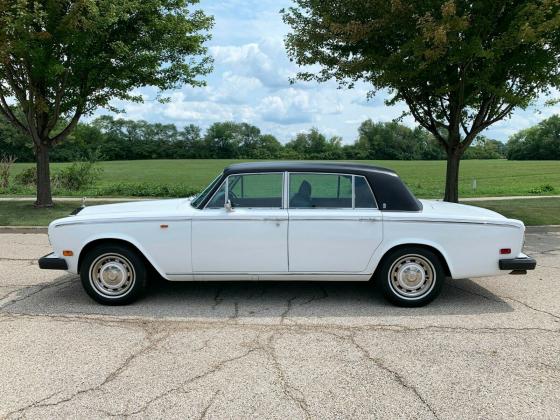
[290,173,352,208]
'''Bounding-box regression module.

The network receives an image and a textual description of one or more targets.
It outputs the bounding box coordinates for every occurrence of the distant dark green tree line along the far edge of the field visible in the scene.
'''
[0,116,560,162]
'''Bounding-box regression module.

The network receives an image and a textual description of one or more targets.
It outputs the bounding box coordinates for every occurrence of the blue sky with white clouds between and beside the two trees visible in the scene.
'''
[100,0,560,143]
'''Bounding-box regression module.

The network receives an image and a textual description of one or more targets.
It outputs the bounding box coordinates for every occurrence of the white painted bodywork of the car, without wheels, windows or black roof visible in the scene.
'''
[44,164,527,281]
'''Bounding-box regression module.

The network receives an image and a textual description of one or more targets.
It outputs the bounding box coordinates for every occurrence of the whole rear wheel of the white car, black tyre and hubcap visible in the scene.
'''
[376,247,445,307]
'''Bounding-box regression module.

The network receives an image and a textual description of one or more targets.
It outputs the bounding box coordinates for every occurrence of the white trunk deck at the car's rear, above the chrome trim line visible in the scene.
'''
[420,200,523,227]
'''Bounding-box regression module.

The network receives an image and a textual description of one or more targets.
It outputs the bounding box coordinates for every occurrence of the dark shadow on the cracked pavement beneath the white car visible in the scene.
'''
[0,275,513,320]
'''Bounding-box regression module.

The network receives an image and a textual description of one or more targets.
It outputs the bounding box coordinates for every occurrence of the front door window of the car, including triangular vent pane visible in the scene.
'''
[207,173,283,208]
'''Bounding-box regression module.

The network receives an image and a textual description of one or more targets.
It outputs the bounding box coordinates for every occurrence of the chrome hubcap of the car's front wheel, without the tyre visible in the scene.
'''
[89,254,136,297]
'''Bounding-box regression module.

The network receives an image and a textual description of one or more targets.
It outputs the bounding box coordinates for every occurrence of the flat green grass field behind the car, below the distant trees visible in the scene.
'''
[4,160,560,198]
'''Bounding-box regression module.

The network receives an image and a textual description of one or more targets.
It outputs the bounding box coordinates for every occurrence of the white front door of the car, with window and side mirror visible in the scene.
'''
[191,173,288,279]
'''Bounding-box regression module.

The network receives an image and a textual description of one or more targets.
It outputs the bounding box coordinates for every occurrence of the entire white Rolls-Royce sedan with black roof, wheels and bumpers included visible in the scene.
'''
[39,162,536,306]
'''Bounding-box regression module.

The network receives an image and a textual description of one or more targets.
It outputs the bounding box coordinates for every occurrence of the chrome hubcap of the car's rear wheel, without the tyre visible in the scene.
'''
[388,254,435,300]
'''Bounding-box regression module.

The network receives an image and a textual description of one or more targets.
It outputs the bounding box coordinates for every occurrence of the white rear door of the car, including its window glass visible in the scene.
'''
[288,172,383,273]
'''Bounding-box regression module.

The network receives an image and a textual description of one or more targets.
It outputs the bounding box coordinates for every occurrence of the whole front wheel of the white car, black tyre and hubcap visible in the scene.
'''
[80,244,147,305]
